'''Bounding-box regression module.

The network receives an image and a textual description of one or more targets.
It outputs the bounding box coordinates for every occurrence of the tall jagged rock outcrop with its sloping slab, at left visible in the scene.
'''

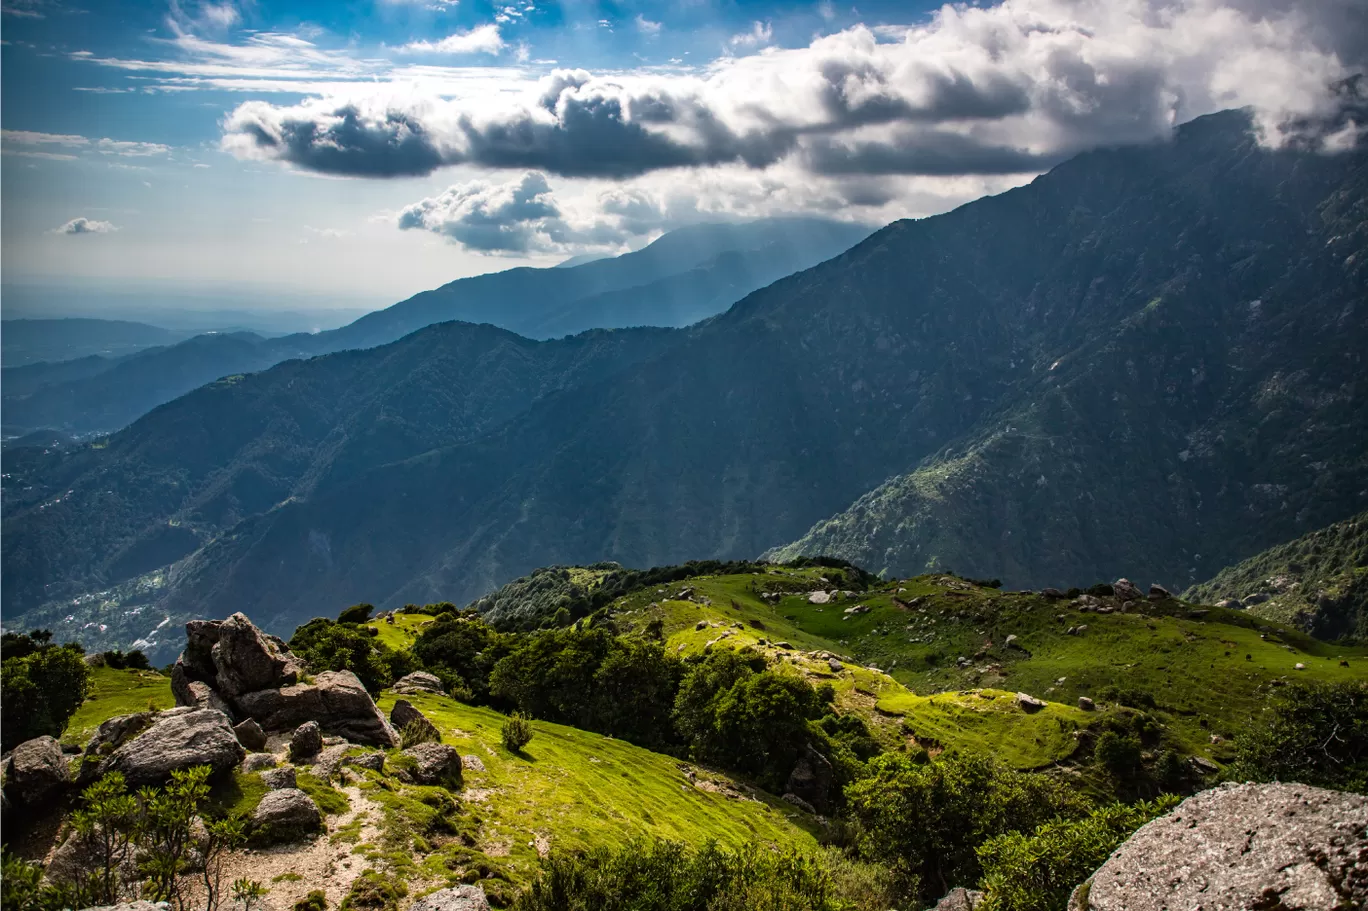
[171,613,398,747]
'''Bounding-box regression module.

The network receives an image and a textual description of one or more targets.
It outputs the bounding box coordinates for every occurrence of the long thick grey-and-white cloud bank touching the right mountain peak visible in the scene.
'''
[222,0,1368,186]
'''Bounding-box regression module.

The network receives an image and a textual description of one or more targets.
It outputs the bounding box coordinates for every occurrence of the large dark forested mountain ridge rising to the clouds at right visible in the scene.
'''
[3,112,1368,653]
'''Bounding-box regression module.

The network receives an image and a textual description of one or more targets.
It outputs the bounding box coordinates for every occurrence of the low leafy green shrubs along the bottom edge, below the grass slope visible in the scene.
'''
[513,840,892,911]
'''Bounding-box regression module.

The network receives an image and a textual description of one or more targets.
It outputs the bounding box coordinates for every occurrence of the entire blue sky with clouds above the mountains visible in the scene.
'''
[0,0,1368,315]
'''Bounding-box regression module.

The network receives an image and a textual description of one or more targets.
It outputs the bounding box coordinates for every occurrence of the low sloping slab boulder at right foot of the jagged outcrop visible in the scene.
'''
[237,670,399,747]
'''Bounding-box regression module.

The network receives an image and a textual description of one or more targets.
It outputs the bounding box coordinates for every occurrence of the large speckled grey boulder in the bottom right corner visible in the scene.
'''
[1070,784,1368,911]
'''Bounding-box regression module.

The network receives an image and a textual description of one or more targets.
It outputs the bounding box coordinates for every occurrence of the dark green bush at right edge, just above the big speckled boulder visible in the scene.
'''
[1227,683,1368,793]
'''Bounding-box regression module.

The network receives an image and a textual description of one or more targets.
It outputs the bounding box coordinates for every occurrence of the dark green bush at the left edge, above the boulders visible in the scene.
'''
[0,633,90,751]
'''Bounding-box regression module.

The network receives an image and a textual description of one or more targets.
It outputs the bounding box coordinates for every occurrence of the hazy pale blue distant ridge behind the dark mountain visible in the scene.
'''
[0,217,870,435]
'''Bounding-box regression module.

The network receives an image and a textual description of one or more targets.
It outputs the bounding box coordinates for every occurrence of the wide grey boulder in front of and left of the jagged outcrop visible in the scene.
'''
[98,707,246,789]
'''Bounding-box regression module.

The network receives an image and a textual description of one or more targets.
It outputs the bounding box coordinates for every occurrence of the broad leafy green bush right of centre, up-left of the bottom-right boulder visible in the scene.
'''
[845,754,1086,899]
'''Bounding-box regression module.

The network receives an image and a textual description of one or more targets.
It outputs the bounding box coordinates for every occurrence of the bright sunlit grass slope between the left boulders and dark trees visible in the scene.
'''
[380,695,815,878]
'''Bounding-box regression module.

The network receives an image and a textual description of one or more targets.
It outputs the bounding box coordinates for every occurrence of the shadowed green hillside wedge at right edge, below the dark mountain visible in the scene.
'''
[1185,513,1368,640]
